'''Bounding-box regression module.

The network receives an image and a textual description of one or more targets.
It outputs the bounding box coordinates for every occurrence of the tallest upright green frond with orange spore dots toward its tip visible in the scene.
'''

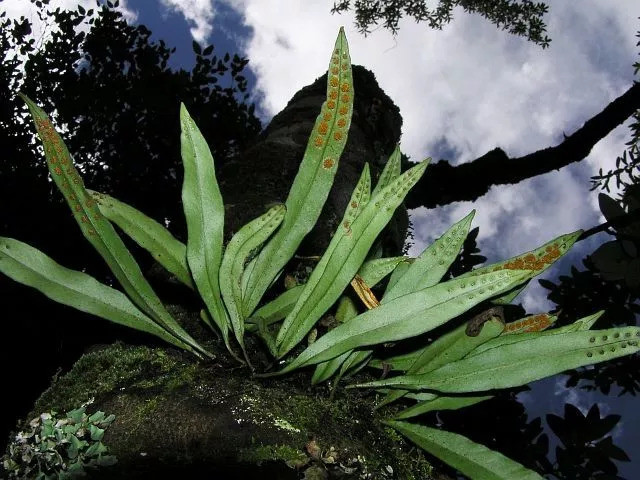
[245,28,354,313]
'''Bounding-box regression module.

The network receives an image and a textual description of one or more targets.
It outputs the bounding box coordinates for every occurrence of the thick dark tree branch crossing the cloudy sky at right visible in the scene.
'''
[406,82,640,208]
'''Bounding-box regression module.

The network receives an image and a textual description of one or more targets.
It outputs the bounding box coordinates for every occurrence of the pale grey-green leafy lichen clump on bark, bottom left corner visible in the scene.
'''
[2,406,116,480]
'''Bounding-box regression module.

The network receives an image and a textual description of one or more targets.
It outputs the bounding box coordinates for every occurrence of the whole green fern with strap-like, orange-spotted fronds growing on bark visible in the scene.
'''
[0,30,640,479]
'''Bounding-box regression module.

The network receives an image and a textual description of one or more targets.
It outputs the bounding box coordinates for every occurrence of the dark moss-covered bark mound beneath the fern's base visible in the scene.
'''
[29,344,431,479]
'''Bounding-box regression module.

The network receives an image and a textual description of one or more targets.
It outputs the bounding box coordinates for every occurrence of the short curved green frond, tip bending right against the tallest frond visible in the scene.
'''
[220,205,286,351]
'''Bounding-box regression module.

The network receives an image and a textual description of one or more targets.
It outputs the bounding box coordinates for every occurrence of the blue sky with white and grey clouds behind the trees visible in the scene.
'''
[5,0,640,476]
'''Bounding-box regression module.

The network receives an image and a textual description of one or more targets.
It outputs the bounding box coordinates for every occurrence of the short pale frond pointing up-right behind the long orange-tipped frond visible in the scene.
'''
[382,210,475,303]
